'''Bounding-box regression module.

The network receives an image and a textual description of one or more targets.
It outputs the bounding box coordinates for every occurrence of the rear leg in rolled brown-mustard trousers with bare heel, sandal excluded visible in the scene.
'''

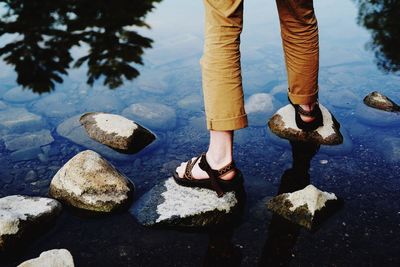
[276,0,319,122]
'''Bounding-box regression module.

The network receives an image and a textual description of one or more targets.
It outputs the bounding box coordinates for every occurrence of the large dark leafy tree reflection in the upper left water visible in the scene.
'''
[0,0,161,92]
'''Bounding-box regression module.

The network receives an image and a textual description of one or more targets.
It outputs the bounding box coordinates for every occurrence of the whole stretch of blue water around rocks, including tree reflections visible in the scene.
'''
[0,0,400,266]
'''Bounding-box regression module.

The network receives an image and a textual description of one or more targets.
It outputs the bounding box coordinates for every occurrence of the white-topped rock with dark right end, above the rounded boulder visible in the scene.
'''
[79,112,155,153]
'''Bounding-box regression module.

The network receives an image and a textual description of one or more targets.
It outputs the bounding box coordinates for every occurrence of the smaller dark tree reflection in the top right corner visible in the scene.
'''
[355,0,400,75]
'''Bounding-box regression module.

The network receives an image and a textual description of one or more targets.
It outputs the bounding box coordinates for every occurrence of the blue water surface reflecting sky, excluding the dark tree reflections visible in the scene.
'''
[0,0,400,266]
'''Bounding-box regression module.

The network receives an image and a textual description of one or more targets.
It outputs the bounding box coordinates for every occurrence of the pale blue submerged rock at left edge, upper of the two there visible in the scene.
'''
[0,108,46,133]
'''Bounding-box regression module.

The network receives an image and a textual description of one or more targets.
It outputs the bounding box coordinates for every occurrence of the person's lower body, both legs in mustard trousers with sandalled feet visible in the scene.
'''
[174,0,322,196]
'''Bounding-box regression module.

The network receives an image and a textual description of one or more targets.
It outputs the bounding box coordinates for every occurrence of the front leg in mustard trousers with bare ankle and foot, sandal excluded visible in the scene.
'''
[176,0,247,180]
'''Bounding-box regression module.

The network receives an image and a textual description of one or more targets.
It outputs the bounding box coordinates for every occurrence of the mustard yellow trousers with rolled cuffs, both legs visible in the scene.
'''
[200,0,319,131]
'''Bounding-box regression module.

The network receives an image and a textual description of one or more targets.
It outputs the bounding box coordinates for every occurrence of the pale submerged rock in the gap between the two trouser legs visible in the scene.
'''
[245,93,276,126]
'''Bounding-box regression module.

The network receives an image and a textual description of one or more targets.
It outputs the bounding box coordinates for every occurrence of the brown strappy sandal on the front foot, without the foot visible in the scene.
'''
[173,153,243,197]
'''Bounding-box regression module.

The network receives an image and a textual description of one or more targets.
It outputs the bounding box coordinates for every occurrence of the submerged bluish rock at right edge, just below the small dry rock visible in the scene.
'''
[355,104,400,127]
